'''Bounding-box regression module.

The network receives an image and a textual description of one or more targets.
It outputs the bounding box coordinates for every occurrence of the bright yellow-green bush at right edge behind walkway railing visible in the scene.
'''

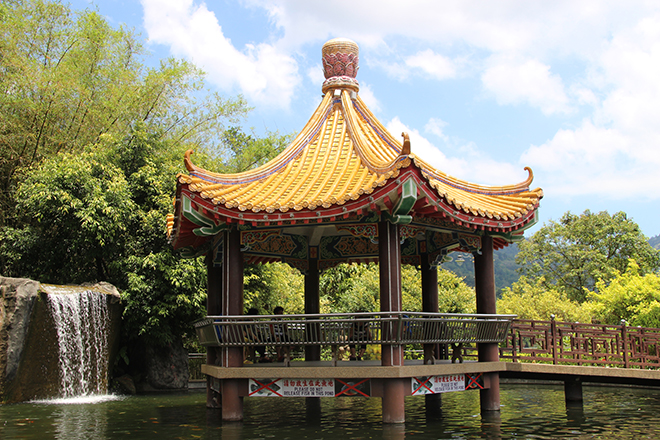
[588,261,660,328]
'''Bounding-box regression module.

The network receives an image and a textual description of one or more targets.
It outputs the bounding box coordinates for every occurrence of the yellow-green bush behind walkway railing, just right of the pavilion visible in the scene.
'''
[497,276,591,323]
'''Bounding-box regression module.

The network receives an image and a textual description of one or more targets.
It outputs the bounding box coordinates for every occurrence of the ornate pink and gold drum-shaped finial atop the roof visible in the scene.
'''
[321,38,360,94]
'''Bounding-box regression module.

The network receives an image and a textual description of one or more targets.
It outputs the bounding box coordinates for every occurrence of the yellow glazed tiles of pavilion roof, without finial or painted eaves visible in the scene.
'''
[178,88,543,220]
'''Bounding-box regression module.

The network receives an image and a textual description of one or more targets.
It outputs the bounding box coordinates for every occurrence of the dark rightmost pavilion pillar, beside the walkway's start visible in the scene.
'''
[474,236,500,413]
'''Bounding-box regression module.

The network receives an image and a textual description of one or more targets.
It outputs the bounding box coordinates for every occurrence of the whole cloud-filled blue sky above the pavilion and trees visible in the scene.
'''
[71,0,660,237]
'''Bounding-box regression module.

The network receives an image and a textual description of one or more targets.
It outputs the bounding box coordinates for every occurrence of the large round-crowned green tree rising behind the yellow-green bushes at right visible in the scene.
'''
[516,210,660,302]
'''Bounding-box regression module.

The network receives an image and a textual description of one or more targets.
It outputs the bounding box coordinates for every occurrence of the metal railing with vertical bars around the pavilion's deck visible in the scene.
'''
[194,312,515,347]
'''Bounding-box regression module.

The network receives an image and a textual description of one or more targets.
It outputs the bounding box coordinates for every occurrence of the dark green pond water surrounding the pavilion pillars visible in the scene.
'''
[0,384,660,440]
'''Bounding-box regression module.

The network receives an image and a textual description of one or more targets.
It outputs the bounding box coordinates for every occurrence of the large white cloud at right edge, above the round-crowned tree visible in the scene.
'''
[521,15,660,200]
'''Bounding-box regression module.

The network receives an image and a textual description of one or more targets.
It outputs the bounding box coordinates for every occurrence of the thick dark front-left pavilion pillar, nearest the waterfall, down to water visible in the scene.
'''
[222,228,243,421]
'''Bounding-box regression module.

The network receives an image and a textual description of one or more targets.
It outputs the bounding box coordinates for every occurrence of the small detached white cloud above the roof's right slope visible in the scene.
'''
[481,57,571,115]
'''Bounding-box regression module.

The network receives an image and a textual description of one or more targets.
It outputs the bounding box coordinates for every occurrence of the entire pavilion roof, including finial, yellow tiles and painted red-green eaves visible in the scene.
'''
[167,39,543,249]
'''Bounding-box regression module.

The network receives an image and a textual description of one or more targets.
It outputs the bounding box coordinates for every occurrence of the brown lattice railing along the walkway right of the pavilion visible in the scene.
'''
[496,319,660,369]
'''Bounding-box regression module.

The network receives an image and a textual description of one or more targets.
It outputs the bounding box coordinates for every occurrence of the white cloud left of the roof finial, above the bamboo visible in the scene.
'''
[142,0,300,108]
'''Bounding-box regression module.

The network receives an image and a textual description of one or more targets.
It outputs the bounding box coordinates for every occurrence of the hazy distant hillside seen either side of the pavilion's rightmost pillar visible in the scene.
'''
[442,243,518,295]
